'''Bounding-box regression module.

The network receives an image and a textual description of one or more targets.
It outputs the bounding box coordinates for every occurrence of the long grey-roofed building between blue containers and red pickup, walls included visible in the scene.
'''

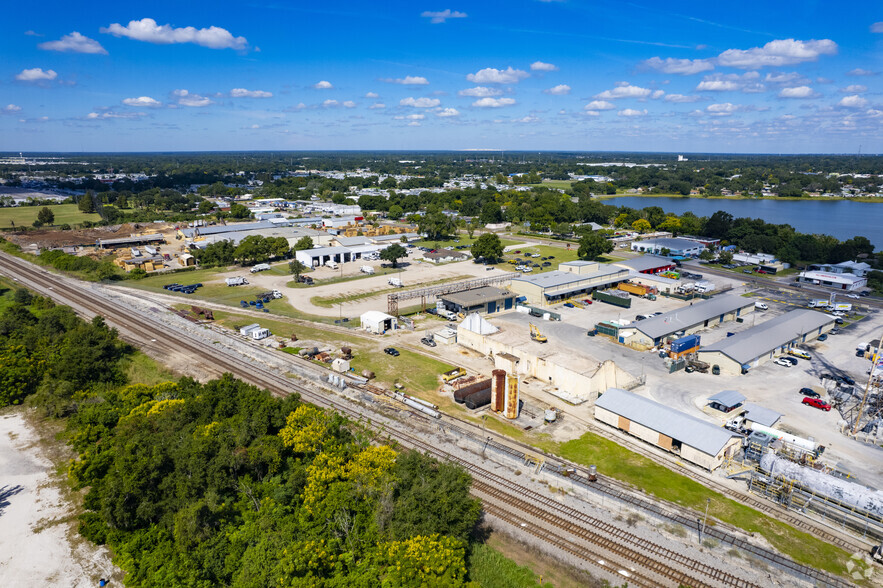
[697,308,834,374]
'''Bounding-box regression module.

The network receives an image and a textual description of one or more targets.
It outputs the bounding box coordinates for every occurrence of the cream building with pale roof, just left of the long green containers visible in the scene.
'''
[509,261,629,304]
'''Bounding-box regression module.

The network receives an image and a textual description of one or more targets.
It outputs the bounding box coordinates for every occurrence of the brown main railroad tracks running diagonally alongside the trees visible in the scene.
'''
[0,255,850,586]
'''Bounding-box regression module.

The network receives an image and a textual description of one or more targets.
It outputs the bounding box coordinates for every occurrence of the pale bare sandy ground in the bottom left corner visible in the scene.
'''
[0,411,123,588]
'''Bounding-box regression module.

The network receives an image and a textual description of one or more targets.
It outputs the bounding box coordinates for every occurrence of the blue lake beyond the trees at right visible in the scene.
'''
[603,196,883,249]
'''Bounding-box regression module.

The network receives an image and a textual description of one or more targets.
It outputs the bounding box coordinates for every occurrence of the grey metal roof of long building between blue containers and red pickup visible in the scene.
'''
[701,308,834,365]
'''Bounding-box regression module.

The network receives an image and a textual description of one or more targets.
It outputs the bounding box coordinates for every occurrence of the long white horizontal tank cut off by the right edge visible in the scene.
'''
[760,453,883,516]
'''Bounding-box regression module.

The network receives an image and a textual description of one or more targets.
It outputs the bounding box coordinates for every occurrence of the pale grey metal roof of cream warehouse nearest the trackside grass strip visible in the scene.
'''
[595,388,740,455]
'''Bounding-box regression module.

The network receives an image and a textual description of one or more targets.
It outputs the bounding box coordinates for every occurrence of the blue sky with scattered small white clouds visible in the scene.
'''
[0,0,883,153]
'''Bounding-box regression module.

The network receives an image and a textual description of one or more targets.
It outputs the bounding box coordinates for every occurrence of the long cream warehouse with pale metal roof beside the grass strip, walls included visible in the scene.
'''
[595,388,742,471]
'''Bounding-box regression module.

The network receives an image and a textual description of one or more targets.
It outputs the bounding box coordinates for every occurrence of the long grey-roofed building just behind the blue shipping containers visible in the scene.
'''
[619,294,754,347]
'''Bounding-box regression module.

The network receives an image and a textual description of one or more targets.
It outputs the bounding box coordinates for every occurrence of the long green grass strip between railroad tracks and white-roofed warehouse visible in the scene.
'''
[541,433,850,575]
